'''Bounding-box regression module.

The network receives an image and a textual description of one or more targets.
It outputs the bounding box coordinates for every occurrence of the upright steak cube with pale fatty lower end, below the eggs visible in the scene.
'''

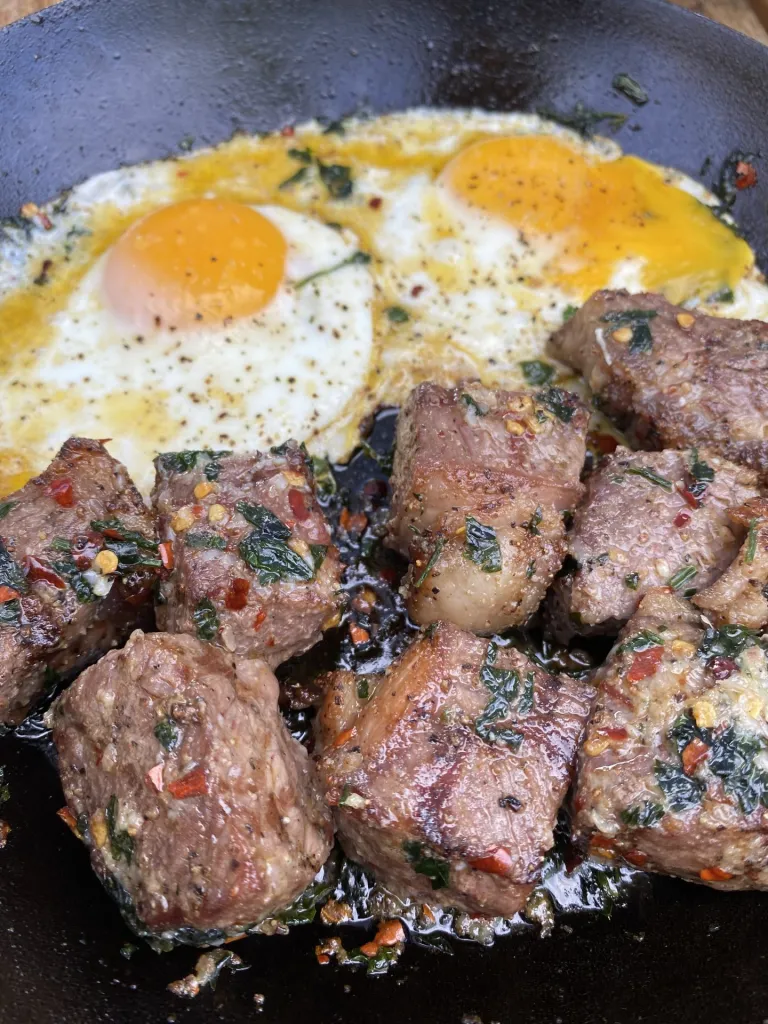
[389,382,589,633]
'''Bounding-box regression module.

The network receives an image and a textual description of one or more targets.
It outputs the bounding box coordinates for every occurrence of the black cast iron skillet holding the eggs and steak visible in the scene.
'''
[0,0,768,1024]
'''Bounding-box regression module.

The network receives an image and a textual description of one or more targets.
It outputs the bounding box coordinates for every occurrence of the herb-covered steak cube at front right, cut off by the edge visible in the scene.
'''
[573,590,768,889]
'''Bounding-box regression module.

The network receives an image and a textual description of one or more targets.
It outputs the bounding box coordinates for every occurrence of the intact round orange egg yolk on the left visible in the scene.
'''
[104,199,287,330]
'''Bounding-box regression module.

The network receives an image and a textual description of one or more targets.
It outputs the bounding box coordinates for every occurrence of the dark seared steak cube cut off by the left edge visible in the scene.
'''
[0,437,162,725]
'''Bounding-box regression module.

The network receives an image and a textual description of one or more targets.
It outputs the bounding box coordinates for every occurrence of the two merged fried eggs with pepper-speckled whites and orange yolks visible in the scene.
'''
[0,110,768,492]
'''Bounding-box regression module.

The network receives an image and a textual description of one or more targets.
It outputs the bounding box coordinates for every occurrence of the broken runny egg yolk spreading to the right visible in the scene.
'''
[443,135,754,302]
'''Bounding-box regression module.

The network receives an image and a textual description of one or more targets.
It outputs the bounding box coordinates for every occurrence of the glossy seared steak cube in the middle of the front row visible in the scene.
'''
[317,623,592,914]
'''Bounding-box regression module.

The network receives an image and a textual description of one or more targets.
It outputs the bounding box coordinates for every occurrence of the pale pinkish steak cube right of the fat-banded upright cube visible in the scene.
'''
[550,447,768,640]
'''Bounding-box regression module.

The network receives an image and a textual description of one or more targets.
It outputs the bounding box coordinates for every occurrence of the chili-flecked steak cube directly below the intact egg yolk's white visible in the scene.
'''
[153,441,342,667]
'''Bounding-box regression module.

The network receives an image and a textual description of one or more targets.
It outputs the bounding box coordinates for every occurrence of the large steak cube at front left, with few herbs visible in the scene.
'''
[50,631,332,944]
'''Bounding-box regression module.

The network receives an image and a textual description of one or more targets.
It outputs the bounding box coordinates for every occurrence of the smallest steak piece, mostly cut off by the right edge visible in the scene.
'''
[693,498,768,630]
